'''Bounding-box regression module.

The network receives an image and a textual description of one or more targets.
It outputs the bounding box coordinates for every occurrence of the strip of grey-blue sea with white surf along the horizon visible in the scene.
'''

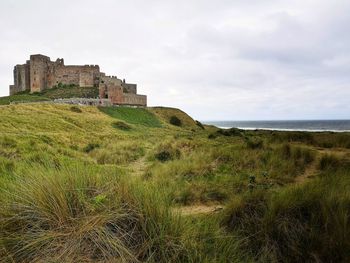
[203,120,350,132]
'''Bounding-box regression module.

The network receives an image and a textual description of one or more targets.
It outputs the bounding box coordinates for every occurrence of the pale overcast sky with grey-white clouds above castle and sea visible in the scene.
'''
[0,0,350,121]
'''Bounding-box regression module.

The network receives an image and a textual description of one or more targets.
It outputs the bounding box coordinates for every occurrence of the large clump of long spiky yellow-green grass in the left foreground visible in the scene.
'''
[0,165,186,262]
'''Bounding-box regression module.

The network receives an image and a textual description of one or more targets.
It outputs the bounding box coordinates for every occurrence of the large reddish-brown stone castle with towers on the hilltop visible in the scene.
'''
[10,54,147,106]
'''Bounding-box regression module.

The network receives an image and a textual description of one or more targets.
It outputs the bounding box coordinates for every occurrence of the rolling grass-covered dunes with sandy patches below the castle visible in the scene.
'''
[0,104,350,262]
